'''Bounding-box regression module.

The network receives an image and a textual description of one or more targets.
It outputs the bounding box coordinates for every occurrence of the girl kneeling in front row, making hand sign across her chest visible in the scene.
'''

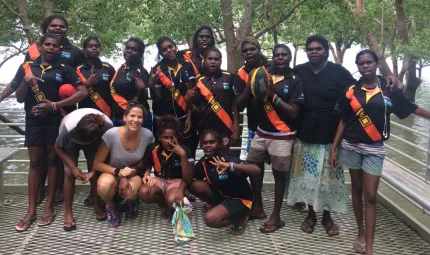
[190,130,260,235]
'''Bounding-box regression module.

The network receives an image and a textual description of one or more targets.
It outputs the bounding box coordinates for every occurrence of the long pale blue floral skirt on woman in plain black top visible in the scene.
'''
[285,140,346,213]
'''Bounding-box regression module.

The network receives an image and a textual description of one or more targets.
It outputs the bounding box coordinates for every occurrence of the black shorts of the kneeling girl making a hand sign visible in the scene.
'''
[209,185,251,220]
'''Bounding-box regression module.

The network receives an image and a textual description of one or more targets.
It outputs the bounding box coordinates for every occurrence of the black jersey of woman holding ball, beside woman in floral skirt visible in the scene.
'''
[257,69,305,135]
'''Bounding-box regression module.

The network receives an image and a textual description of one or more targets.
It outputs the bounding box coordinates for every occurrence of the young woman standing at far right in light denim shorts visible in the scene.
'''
[330,49,430,254]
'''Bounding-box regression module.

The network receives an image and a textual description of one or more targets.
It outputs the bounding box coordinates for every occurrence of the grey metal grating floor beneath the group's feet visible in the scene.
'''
[0,191,430,255]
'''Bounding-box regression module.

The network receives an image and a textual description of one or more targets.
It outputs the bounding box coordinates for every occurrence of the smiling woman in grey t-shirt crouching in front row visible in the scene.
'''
[94,104,154,227]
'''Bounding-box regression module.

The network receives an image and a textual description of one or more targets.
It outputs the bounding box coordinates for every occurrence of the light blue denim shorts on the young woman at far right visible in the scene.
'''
[340,148,385,176]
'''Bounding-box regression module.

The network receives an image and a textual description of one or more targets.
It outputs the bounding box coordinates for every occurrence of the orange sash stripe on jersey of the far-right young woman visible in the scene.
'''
[346,86,382,142]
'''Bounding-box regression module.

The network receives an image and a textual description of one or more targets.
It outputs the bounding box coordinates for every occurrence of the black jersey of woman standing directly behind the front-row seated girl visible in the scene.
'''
[151,61,195,118]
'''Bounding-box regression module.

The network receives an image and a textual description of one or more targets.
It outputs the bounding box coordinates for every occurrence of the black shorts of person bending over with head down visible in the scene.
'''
[64,138,101,172]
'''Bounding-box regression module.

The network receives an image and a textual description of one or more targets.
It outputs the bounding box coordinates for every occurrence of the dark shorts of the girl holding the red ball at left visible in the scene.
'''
[24,125,59,147]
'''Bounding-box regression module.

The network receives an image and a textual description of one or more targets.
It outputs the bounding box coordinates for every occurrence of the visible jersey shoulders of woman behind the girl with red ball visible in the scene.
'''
[25,38,85,68]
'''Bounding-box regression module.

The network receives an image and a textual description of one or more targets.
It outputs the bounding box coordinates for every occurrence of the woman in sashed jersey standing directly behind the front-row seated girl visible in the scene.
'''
[149,36,195,155]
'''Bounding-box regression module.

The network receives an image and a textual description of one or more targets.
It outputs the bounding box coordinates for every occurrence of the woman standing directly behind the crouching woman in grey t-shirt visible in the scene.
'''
[110,37,152,130]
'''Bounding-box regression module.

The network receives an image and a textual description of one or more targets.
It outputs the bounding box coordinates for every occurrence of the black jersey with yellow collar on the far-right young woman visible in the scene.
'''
[334,77,418,144]
